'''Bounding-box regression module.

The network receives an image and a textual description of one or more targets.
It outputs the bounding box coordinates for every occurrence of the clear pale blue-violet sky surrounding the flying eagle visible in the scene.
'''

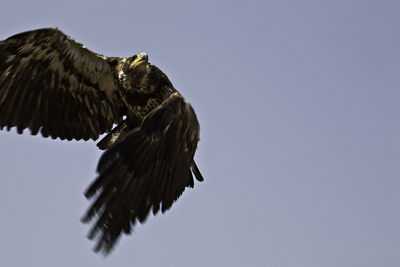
[0,0,400,267]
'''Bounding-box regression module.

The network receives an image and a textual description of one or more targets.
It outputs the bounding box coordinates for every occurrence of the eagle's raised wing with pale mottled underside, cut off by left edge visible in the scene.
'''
[0,28,122,140]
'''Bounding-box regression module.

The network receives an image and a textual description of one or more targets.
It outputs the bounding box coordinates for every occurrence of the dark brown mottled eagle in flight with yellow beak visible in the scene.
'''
[0,28,204,254]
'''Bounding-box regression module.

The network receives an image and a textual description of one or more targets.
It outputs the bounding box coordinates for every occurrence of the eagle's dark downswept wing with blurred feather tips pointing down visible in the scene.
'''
[82,93,203,253]
